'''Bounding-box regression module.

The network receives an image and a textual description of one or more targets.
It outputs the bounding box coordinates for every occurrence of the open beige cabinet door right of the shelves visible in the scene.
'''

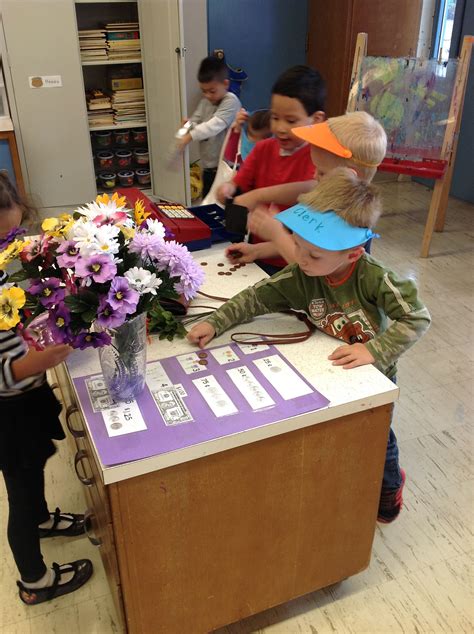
[138,0,190,204]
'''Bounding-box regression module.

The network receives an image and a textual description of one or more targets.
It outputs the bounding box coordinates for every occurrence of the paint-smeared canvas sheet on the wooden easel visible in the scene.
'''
[351,57,457,160]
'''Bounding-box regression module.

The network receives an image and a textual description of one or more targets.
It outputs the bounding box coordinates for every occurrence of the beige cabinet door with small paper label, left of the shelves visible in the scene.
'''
[1,0,95,207]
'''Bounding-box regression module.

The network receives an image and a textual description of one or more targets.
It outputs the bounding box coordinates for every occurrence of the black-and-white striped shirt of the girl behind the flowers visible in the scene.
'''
[0,271,46,398]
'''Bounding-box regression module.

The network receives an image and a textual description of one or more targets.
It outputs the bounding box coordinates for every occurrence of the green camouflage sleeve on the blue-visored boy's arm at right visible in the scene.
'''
[365,271,431,372]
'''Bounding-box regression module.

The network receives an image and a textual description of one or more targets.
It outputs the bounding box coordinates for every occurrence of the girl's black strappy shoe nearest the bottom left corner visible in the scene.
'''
[16,559,94,605]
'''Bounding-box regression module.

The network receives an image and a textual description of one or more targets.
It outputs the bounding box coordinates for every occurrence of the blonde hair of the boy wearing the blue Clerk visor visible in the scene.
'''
[298,167,382,227]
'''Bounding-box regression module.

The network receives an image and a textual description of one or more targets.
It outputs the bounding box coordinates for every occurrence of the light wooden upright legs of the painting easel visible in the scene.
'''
[347,33,474,258]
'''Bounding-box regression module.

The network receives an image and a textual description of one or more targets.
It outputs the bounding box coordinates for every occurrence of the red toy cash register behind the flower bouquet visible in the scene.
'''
[117,187,211,251]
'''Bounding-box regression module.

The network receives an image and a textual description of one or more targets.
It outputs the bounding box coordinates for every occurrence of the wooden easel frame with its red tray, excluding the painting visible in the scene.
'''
[347,33,474,258]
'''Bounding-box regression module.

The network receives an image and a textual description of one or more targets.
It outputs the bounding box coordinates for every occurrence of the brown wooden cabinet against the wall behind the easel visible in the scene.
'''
[307,0,423,117]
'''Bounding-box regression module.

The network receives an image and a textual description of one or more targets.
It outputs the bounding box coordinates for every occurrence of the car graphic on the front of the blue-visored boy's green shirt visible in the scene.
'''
[308,298,375,343]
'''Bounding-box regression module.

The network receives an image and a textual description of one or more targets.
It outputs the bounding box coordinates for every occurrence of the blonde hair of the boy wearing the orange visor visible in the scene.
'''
[328,111,387,182]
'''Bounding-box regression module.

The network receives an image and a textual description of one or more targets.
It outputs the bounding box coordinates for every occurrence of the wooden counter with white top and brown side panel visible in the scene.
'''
[56,247,398,634]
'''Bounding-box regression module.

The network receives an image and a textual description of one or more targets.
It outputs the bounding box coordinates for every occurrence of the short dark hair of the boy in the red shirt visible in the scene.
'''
[272,66,327,116]
